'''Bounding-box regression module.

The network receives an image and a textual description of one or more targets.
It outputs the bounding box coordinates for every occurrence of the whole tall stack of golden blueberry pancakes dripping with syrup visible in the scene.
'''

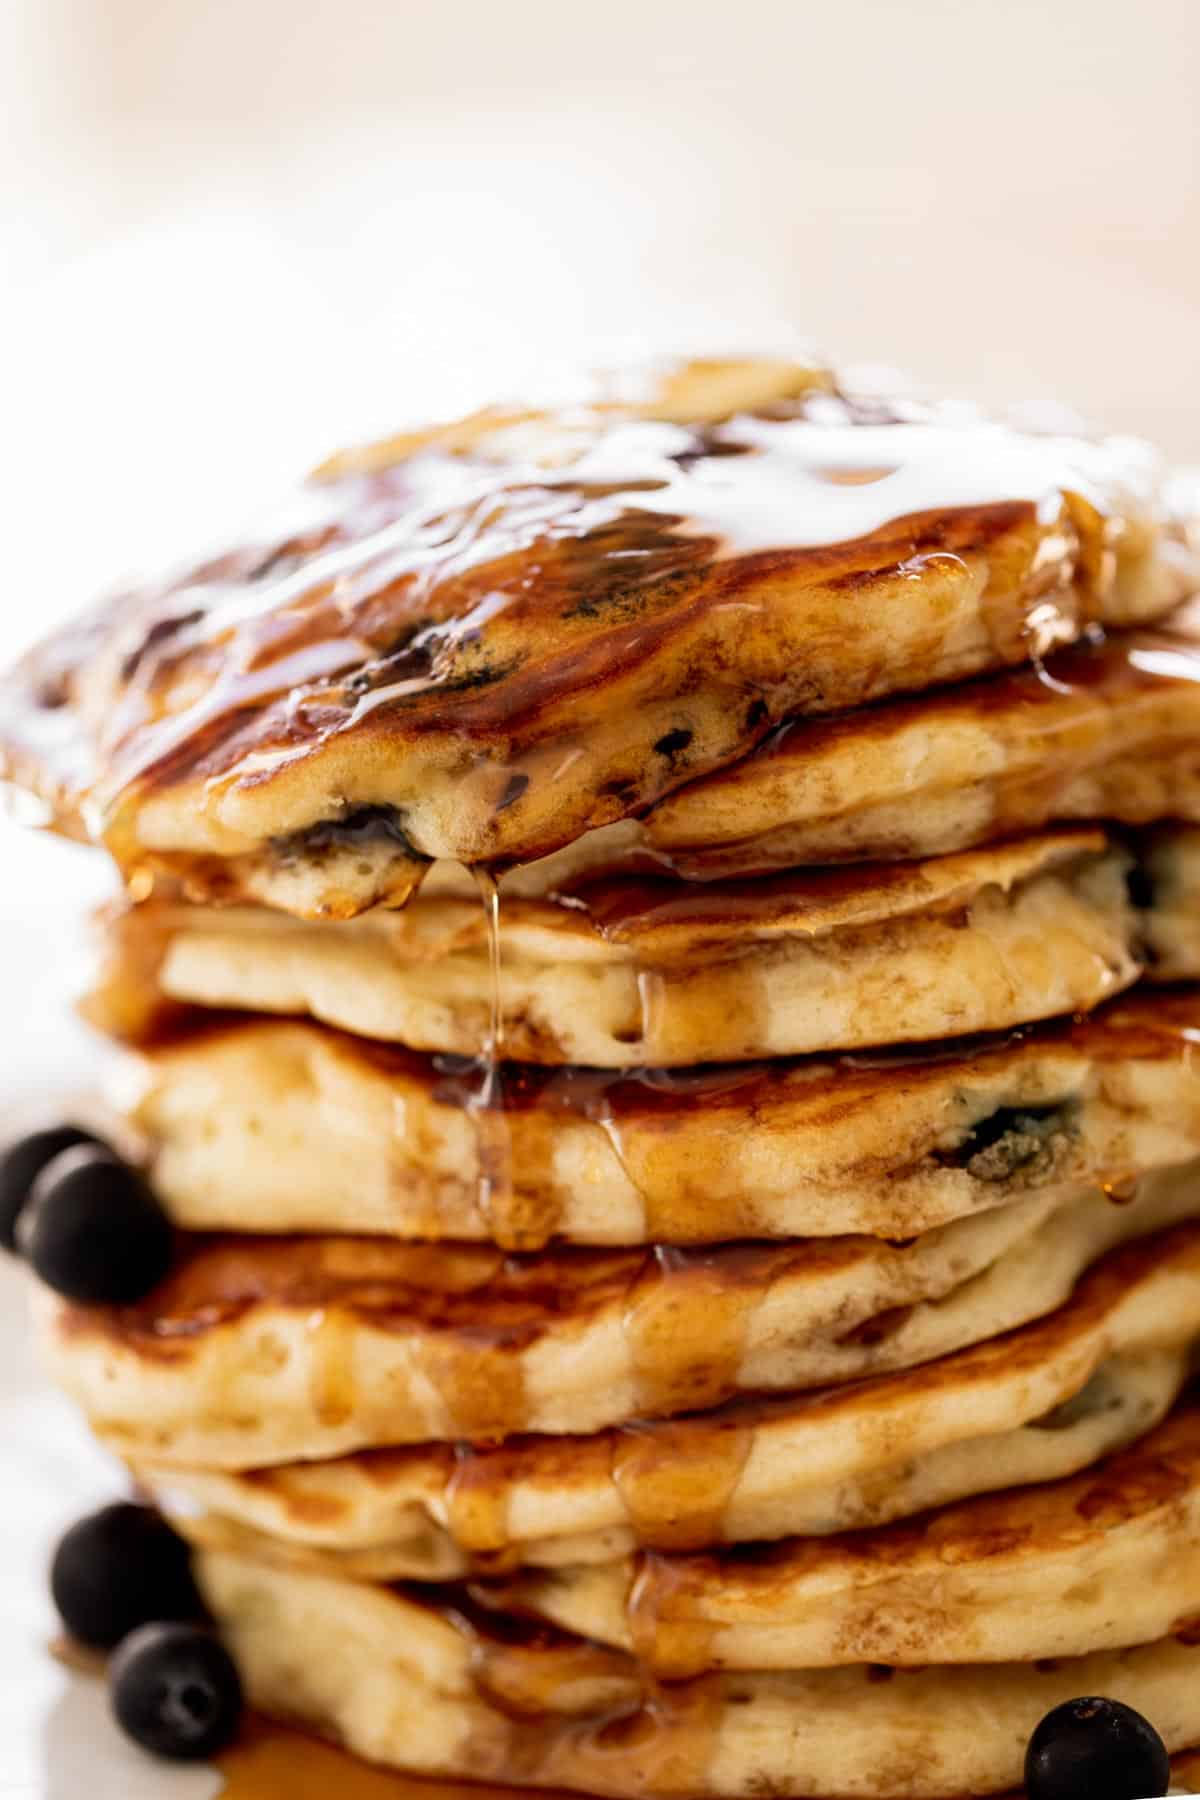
[0,362,1200,1800]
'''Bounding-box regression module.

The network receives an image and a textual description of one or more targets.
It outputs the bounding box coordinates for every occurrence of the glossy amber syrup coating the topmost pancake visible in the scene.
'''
[4,369,1182,928]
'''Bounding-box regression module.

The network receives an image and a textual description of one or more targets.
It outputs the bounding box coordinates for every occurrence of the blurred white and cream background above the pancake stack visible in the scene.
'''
[0,0,1200,662]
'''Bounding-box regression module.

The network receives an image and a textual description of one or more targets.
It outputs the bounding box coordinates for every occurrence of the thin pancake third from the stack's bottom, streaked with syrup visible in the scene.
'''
[145,1352,1187,1580]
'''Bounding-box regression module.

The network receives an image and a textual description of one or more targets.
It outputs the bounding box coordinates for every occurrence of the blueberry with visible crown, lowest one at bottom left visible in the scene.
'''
[108,1625,241,1762]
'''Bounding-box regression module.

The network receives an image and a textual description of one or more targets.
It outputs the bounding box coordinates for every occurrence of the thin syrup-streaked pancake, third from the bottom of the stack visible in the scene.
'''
[141,1328,1189,1580]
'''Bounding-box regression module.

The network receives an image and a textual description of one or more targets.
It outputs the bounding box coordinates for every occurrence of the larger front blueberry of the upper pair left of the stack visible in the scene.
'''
[18,1145,171,1305]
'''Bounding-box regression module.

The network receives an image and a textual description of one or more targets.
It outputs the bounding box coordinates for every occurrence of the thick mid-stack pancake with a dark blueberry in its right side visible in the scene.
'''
[112,988,1200,1249]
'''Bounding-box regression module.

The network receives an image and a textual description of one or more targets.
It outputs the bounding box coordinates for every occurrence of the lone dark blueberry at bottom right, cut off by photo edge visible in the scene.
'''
[1025,1699,1171,1800]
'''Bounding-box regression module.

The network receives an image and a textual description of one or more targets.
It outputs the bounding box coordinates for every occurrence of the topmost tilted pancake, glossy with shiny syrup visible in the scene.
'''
[0,362,1200,918]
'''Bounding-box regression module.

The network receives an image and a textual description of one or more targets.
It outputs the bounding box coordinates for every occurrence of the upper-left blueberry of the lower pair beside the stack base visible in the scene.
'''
[50,1501,203,1651]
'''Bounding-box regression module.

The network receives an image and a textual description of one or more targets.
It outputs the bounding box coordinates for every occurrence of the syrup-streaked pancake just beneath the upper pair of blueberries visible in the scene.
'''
[30,1168,1200,1463]
